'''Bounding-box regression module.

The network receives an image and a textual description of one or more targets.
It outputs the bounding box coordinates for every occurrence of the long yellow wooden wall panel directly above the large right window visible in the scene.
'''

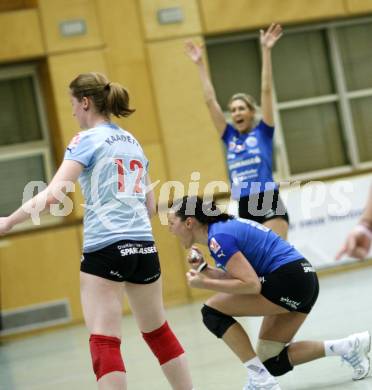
[199,0,348,33]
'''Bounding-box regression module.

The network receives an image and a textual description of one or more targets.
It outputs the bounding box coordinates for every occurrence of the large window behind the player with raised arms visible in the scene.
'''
[207,19,372,179]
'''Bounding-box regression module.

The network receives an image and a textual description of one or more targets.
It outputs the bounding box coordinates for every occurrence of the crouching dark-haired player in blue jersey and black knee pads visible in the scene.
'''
[168,196,371,390]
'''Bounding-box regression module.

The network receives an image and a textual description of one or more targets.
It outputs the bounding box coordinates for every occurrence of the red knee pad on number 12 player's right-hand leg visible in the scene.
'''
[142,322,185,365]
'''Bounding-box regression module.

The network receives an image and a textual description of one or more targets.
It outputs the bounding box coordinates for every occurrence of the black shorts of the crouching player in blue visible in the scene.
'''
[260,259,319,314]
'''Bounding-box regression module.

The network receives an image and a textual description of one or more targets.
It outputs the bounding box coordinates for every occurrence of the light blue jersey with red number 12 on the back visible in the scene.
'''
[65,124,153,252]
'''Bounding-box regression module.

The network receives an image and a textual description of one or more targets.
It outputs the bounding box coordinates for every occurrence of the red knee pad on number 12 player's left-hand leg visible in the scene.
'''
[89,334,125,381]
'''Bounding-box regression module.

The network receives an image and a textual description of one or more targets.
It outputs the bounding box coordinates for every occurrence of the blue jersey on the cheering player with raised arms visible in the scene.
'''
[222,121,278,199]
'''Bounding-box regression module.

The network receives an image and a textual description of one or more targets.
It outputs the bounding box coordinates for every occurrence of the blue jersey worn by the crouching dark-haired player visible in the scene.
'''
[208,218,303,276]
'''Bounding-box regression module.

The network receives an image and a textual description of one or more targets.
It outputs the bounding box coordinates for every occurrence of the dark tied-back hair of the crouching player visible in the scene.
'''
[172,196,234,225]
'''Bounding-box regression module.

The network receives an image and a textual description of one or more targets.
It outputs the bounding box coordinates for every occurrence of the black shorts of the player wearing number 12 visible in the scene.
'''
[80,240,161,284]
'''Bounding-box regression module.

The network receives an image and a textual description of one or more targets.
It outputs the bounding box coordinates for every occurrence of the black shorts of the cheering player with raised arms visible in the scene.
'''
[239,190,289,224]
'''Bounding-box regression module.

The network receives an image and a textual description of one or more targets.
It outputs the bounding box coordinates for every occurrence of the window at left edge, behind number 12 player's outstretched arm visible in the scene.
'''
[0,65,52,216]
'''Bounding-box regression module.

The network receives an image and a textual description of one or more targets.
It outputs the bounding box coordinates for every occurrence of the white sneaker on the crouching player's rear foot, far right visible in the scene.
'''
[341,332,371,381]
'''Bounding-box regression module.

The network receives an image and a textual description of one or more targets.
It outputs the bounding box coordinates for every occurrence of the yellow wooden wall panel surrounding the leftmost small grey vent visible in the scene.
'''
[39,0,103,53]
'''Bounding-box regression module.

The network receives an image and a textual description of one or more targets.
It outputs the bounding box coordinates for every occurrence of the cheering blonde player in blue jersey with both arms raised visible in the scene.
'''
[186,23,289,238]
